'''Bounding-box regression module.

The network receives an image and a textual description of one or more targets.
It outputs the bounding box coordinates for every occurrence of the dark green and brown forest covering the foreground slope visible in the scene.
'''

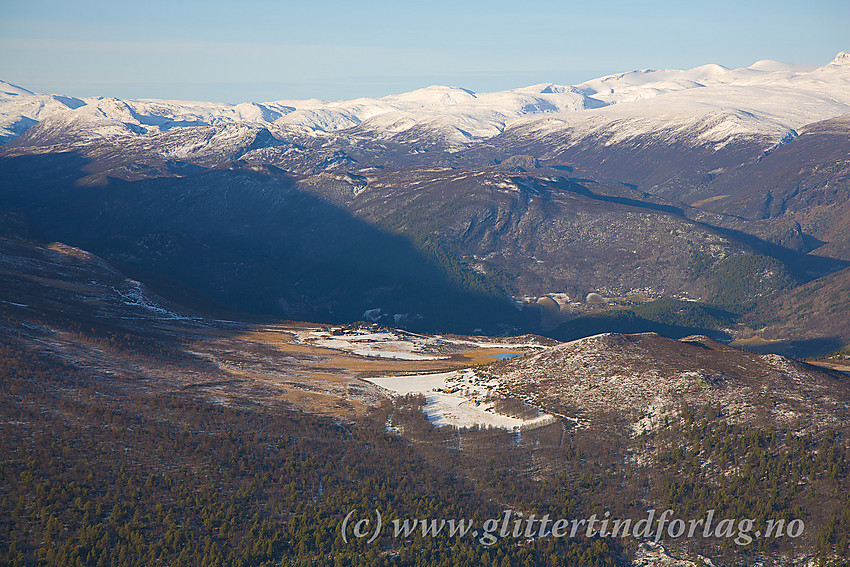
[0,328,850,567]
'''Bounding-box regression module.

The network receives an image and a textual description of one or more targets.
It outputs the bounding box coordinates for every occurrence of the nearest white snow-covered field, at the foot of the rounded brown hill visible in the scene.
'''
[369,369,553,429]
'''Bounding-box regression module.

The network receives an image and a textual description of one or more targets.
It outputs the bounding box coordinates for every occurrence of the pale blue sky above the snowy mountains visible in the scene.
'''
[0,0,850,102]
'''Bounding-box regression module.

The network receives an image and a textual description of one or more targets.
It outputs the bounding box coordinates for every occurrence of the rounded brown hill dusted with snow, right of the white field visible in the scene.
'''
[494,333,850,430]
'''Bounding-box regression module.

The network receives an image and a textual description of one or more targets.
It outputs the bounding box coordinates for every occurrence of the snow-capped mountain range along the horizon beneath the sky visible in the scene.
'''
[0,52,850,151]
